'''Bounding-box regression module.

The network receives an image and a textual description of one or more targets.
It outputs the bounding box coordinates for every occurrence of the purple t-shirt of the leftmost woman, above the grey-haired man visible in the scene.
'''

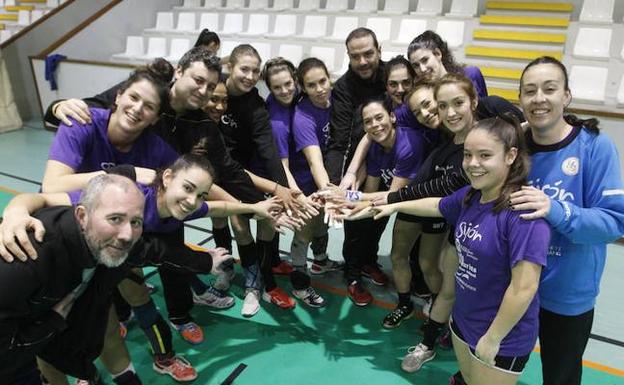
[48,108,178,173]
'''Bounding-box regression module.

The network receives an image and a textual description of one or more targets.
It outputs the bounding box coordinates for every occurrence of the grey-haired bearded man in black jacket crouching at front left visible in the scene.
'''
[0,175,223,384]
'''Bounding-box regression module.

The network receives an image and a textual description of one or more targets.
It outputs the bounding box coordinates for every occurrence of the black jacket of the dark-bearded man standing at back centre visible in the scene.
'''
[325,61,386,184]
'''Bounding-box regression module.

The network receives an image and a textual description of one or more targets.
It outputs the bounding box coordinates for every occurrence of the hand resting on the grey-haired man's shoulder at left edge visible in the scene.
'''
[0,212,45,262]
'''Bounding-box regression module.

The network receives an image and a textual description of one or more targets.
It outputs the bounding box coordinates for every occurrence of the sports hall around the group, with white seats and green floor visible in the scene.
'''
[0,0,624,385]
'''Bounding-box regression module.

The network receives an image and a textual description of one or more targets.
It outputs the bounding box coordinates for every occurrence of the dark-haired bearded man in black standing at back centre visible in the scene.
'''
[325,28,386,306]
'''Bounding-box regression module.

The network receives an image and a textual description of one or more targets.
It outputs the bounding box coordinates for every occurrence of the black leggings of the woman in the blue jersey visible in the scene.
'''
[539,309,594,385]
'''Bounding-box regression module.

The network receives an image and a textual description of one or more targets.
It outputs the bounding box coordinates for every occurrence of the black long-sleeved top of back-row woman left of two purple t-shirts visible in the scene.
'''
[219,88,288,187]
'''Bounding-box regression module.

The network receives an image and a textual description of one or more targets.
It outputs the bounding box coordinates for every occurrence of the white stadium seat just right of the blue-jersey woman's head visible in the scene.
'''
[570,65,609,103]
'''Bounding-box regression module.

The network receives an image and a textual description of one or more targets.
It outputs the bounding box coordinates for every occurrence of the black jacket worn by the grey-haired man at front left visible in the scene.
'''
[0,206,212,383]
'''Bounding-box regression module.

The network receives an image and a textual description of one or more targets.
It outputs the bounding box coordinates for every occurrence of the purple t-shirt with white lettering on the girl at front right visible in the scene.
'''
[439,186,550,356]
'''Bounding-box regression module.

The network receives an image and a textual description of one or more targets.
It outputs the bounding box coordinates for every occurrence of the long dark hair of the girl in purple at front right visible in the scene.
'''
[464,113,531,212]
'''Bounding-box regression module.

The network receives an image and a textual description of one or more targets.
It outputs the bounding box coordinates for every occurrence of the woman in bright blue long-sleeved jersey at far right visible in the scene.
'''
[511,56,624,385]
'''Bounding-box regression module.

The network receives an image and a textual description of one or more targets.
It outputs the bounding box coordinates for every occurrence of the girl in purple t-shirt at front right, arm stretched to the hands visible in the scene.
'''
[372,117,550,385]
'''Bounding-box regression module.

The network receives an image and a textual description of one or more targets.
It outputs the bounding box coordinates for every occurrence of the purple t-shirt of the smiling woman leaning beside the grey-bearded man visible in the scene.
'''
[68,184,209,234]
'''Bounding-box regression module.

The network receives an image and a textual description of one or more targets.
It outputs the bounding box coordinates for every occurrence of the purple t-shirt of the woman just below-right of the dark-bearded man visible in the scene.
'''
[366,126,426,191]
